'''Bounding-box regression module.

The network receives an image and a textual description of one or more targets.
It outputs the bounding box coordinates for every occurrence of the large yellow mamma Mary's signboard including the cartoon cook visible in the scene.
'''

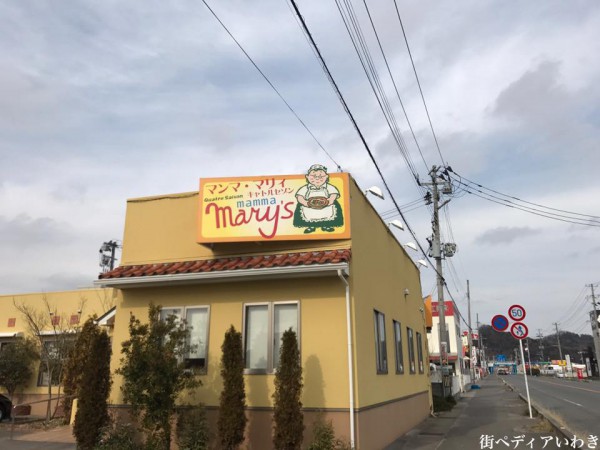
[198,164,350,243]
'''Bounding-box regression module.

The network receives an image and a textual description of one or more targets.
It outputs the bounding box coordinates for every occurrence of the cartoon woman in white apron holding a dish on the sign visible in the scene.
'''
[294,164,344,234]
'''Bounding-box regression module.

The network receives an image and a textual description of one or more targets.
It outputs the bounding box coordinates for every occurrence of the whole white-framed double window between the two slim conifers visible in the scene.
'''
[243,301,300,373]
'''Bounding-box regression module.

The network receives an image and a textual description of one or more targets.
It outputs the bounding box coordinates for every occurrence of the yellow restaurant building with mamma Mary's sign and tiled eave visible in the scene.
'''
[0,166,431,450]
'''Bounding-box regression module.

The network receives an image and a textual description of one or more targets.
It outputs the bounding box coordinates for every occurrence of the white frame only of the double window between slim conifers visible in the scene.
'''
[242,300,302,375]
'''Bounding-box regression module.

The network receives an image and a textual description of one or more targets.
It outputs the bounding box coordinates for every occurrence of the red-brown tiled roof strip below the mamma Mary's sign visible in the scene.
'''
[99,249,351,279]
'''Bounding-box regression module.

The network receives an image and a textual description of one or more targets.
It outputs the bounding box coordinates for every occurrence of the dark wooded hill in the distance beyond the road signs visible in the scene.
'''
[479,325,594,363]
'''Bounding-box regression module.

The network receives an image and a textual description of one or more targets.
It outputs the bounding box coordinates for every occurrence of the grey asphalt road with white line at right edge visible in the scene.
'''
[501,374,600,437]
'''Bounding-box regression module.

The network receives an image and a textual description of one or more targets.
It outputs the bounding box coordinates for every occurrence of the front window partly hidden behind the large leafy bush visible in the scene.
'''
[160,306,210,372]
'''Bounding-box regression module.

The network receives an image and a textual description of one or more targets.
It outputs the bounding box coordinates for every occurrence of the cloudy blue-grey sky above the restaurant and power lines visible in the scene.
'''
[0,0,600,336]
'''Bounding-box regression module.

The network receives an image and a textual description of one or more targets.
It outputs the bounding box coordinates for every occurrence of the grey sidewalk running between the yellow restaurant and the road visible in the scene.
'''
[385,375,568,450]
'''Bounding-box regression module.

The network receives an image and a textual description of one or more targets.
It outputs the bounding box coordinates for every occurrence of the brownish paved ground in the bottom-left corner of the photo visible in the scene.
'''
[0,425,77,450]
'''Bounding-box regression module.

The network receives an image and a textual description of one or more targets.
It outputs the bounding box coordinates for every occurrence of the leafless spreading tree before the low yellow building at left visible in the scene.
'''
[13,295,86,421]
